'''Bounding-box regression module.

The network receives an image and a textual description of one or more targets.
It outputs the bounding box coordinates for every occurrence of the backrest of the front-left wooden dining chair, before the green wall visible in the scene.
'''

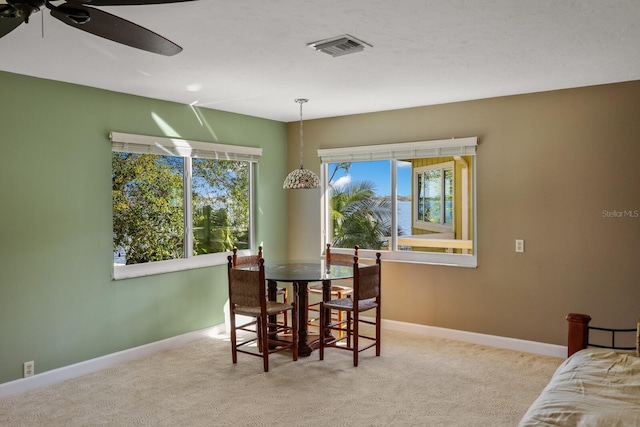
[227,256,266,307]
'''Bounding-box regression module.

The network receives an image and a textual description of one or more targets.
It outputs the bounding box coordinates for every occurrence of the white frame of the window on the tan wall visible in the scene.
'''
[318,137,478,268]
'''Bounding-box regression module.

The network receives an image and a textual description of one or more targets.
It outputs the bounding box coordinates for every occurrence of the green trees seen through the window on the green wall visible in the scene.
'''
[112,152,249,264]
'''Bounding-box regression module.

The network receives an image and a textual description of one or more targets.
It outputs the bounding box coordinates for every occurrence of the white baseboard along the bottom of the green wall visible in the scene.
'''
[0,325,224,399]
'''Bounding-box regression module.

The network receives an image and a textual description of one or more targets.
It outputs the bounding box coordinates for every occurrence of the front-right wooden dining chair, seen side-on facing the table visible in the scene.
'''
[319,252,381,366]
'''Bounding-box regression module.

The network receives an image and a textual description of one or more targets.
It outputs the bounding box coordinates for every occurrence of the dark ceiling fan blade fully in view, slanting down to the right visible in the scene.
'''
[50,3,182,56]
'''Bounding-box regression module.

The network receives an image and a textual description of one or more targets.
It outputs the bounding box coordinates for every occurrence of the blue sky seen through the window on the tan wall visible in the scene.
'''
[329,160,411,196]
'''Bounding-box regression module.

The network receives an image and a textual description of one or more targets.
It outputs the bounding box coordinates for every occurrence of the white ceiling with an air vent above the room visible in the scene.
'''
[0,0,640,122]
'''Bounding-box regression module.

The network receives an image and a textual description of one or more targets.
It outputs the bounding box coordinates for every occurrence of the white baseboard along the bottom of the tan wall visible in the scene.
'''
[381,319,567,358]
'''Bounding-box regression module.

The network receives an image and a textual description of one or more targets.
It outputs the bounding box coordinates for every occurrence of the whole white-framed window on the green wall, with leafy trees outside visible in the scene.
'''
[111,132,262,279]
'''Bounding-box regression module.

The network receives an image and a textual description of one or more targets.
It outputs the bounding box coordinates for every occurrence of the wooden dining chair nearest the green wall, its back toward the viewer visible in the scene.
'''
[227,255,298,372]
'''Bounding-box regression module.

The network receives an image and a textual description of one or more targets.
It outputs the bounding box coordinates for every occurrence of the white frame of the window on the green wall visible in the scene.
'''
[109,132,262,280]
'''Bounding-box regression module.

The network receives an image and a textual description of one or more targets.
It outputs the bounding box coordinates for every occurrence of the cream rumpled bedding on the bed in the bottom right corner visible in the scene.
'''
[519,348,640,427]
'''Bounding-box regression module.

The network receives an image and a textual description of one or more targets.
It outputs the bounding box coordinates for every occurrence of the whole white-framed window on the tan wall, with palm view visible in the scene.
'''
[318,138,477,267]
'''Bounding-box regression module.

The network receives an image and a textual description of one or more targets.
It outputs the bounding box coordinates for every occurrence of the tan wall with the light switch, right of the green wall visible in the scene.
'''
[288,82,640,344]
